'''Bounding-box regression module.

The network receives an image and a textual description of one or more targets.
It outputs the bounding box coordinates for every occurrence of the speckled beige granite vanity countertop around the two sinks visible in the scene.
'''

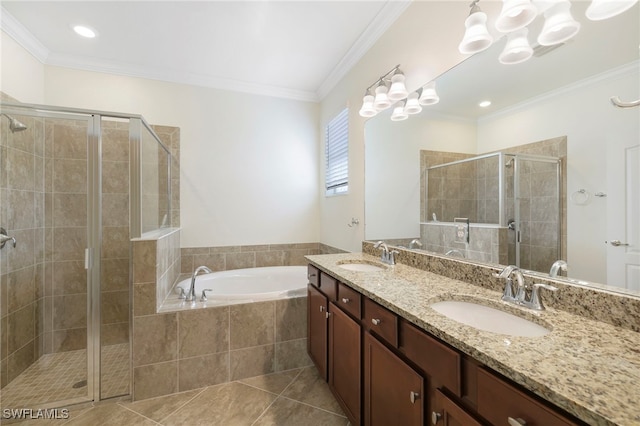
[306,253,640,425]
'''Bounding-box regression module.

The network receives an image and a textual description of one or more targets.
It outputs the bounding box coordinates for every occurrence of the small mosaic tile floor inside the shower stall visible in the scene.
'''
[0,344,130,408]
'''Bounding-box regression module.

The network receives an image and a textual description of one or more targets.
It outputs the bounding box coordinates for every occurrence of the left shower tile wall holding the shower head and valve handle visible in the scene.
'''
[0,110,45,387]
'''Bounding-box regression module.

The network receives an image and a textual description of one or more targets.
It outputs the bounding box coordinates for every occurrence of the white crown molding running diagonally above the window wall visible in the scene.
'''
[316,0,413,100]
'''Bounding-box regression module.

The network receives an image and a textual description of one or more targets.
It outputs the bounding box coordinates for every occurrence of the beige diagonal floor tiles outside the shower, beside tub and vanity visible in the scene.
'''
[5,367,349,426]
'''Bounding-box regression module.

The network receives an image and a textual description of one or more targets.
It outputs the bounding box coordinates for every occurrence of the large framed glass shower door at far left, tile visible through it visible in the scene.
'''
[0,110,99,409]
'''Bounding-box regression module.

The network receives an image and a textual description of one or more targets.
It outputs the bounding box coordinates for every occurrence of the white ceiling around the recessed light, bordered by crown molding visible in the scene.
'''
[1,0,410,101]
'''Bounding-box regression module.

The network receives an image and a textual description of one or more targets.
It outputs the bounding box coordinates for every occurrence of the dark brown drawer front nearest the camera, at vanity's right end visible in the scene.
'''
[478,368,580,426]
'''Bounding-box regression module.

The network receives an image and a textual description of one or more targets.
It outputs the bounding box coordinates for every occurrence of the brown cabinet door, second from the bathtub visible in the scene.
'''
[329,303,361,425]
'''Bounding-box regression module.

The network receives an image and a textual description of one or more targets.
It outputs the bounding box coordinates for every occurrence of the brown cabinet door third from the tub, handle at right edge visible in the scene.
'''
[364,333,424,426]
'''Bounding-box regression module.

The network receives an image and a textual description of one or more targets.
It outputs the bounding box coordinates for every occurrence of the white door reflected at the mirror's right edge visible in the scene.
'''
[607,141,640,292]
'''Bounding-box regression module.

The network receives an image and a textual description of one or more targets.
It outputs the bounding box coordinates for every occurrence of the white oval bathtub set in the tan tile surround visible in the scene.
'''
[176,266,308,301]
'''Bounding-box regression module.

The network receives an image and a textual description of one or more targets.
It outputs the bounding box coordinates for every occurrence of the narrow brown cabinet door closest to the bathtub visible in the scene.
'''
[307,284,328,381]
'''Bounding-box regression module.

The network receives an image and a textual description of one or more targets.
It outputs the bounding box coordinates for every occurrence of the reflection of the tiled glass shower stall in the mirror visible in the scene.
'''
[420,152,564,272]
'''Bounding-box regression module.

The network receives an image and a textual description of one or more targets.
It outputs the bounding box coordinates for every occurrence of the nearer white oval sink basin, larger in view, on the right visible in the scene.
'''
[430,300,551,337]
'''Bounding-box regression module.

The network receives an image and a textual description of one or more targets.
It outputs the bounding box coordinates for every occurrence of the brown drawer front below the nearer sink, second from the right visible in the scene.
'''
[400,321,461,396]
